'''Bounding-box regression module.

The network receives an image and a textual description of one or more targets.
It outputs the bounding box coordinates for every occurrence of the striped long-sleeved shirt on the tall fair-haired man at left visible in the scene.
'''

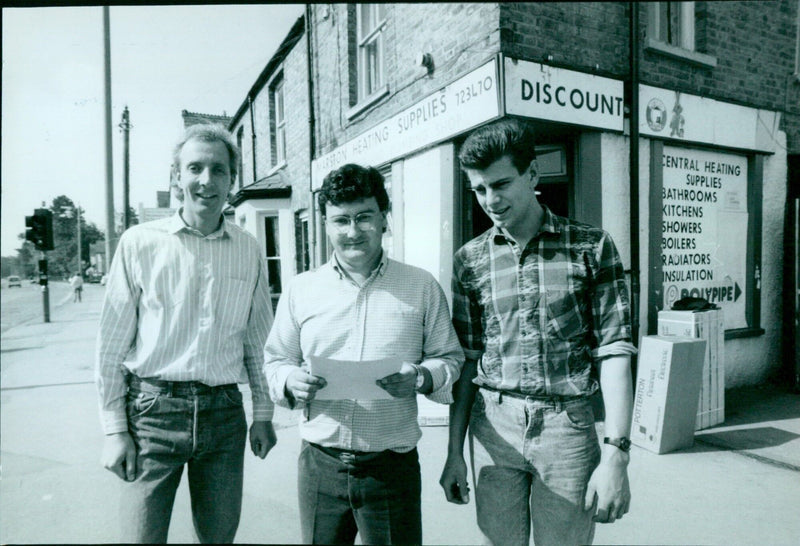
[95,212,274,434]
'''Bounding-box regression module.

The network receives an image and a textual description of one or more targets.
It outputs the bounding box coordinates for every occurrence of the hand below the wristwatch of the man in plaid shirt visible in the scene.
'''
[584,448,631,523]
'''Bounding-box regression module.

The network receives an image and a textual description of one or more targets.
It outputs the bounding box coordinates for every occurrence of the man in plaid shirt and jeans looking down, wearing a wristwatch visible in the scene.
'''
[440,119,636,545]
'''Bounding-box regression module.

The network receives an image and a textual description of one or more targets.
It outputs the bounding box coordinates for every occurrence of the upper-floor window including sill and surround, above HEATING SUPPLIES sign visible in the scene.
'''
[348,4,389,117]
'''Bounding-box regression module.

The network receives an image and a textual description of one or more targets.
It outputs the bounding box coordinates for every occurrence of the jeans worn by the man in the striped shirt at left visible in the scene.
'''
[120,377,247,543]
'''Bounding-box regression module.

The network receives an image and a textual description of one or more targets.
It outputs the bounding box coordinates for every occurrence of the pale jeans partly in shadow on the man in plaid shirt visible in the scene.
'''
[469,389,600,546]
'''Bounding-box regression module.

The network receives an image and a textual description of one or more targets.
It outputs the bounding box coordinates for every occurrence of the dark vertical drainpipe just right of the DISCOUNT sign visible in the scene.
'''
[628,2,640,348]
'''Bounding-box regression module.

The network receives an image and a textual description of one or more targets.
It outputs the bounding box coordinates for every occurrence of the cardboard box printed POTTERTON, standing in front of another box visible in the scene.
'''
[631,336,706,453]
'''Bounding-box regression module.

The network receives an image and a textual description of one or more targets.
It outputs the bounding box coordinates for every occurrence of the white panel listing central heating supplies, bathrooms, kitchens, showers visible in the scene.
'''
[661,146,749,329]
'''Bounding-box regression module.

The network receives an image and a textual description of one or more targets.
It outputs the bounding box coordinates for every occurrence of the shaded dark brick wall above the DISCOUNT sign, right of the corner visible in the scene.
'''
[500,0,800,153]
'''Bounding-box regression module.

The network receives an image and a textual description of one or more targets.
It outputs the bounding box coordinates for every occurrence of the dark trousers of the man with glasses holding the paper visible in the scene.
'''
[297,441,422,544]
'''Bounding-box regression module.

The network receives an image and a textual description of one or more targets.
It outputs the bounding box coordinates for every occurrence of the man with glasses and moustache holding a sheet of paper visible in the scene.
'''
[265,164,463,544]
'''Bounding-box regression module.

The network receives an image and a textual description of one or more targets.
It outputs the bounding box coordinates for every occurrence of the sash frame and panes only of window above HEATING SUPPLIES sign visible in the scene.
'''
[357,4,386,102]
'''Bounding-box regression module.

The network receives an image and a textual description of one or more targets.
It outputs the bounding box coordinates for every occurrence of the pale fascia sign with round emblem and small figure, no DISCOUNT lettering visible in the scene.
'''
[639,85,780,153]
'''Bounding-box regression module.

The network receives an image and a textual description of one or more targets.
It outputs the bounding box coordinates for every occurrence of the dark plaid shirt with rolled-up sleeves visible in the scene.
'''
[453,207,636,396]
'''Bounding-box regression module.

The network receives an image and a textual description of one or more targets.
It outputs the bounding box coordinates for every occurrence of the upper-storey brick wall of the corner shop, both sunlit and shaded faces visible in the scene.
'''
[312,0,800,156]
